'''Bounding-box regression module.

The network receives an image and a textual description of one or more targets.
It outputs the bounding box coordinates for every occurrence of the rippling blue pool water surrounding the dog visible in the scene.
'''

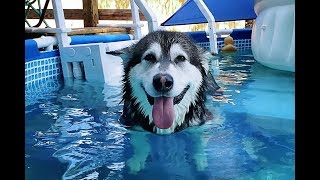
[25,50,295,180]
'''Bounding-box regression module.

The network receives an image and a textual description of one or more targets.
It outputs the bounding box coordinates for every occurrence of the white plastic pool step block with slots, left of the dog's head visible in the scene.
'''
[60,40,136,84]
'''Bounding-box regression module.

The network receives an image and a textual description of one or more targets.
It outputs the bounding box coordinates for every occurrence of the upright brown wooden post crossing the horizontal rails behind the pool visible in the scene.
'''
[82,0,99,27]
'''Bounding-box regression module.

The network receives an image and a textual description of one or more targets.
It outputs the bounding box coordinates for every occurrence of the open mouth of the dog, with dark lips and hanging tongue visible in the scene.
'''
[142,85,190,129]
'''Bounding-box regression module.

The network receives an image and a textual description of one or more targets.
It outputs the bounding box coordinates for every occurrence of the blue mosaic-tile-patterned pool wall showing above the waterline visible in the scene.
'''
[25,39,251,87]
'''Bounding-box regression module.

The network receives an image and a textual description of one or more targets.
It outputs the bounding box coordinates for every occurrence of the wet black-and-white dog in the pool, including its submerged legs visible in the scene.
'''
[107,31,220,173]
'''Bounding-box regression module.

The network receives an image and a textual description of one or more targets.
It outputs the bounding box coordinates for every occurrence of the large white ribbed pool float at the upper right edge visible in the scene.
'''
[251,0,295,72]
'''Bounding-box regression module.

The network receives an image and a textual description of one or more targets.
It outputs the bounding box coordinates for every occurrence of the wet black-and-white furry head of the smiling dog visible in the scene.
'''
[112,31,215,134]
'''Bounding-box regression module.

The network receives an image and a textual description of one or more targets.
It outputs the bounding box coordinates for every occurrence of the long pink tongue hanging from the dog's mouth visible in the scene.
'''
[152,97,174,129]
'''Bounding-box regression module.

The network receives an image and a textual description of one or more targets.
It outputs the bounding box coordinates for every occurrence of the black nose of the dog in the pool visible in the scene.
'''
[153,74,173,92]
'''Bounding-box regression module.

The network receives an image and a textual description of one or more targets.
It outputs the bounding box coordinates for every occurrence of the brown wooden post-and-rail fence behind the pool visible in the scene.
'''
[26,0,146,35]
